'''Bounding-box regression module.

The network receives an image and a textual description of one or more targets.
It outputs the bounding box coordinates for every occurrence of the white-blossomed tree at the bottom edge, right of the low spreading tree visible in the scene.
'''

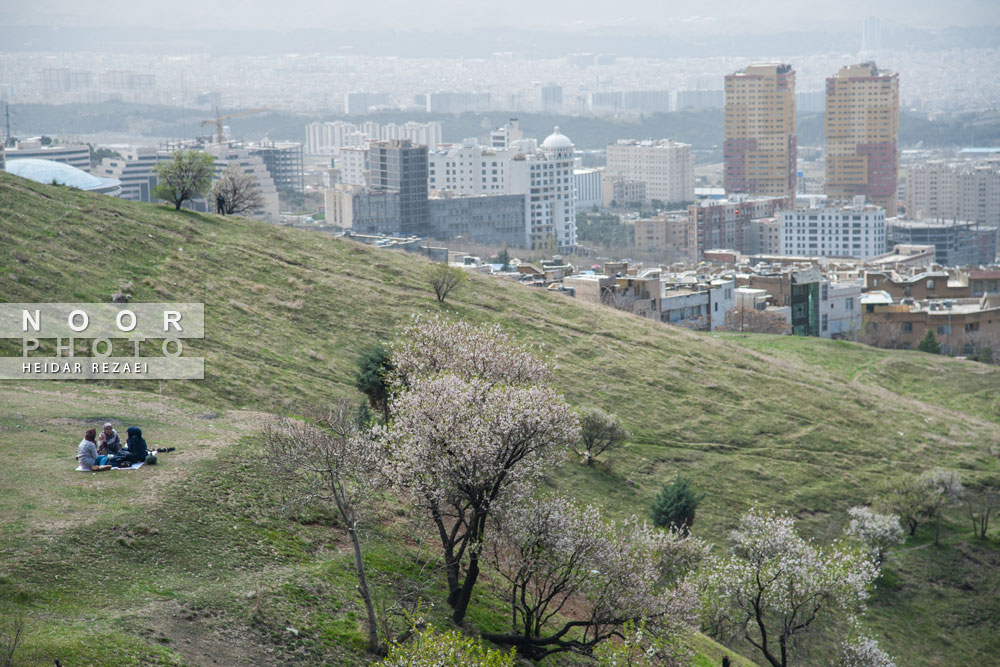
[701,510,878,667]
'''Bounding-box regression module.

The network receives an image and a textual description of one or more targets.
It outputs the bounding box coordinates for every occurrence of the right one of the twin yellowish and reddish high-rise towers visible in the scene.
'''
[826,62,899,211]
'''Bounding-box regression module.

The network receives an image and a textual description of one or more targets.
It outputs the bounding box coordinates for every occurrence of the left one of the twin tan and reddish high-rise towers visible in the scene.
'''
[723,63,797,202]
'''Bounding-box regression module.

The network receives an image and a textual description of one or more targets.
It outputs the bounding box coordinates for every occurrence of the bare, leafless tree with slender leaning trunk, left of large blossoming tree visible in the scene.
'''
[264,401,384,653]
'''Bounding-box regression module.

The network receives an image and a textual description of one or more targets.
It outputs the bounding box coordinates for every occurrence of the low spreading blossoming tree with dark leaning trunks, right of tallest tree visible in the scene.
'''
[483,497,702,660]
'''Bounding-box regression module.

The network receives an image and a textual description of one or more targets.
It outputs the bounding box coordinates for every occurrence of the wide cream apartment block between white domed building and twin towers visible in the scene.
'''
[605,139,694,203]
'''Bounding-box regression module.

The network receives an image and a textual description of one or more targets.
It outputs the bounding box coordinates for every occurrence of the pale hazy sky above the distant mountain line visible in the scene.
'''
[0,0,1000,32]
